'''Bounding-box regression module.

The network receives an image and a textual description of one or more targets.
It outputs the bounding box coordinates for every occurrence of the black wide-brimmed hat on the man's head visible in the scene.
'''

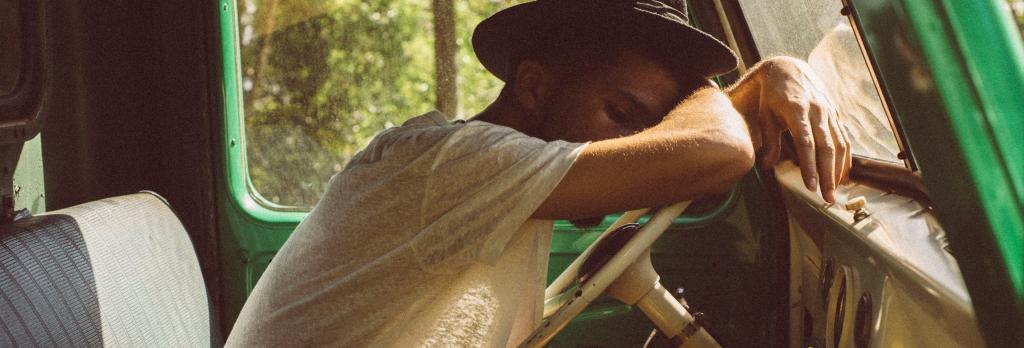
[473,0,737,81]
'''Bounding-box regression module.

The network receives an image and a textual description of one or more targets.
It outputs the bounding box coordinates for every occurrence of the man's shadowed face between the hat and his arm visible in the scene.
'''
[539,51,709,142]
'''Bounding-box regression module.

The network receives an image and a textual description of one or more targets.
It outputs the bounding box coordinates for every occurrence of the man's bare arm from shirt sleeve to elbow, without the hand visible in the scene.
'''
[532,88,754,219]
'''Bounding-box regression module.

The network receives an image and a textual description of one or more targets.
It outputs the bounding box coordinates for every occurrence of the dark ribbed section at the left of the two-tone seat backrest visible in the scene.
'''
[0,215,102,347]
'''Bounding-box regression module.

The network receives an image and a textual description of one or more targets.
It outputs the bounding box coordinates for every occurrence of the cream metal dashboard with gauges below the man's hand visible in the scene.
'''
[776,163,984,347]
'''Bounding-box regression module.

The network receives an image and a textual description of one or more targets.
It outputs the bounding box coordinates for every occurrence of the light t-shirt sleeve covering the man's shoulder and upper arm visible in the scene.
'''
[414,123,586,273]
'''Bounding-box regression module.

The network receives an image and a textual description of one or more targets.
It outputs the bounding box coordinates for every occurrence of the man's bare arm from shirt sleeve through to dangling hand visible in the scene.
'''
[532,57,851,219]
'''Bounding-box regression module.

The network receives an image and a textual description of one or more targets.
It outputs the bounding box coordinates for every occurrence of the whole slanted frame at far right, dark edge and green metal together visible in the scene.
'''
[849,0,1024,347]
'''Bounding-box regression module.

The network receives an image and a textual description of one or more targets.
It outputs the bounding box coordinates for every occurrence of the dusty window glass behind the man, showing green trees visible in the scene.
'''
[238,0,522,207]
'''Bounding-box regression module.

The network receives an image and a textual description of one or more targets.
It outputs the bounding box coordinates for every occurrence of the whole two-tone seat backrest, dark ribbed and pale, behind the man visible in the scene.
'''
[0,192,211,347]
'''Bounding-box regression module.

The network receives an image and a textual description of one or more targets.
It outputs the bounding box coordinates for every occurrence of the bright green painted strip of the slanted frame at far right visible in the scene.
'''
[940,0,1024,290]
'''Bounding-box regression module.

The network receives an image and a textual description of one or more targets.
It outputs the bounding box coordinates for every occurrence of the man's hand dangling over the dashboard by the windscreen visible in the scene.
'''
[727,57,852,203]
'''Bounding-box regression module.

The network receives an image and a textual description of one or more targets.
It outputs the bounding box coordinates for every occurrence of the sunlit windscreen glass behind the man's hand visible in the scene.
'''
[739,0,902,163]
